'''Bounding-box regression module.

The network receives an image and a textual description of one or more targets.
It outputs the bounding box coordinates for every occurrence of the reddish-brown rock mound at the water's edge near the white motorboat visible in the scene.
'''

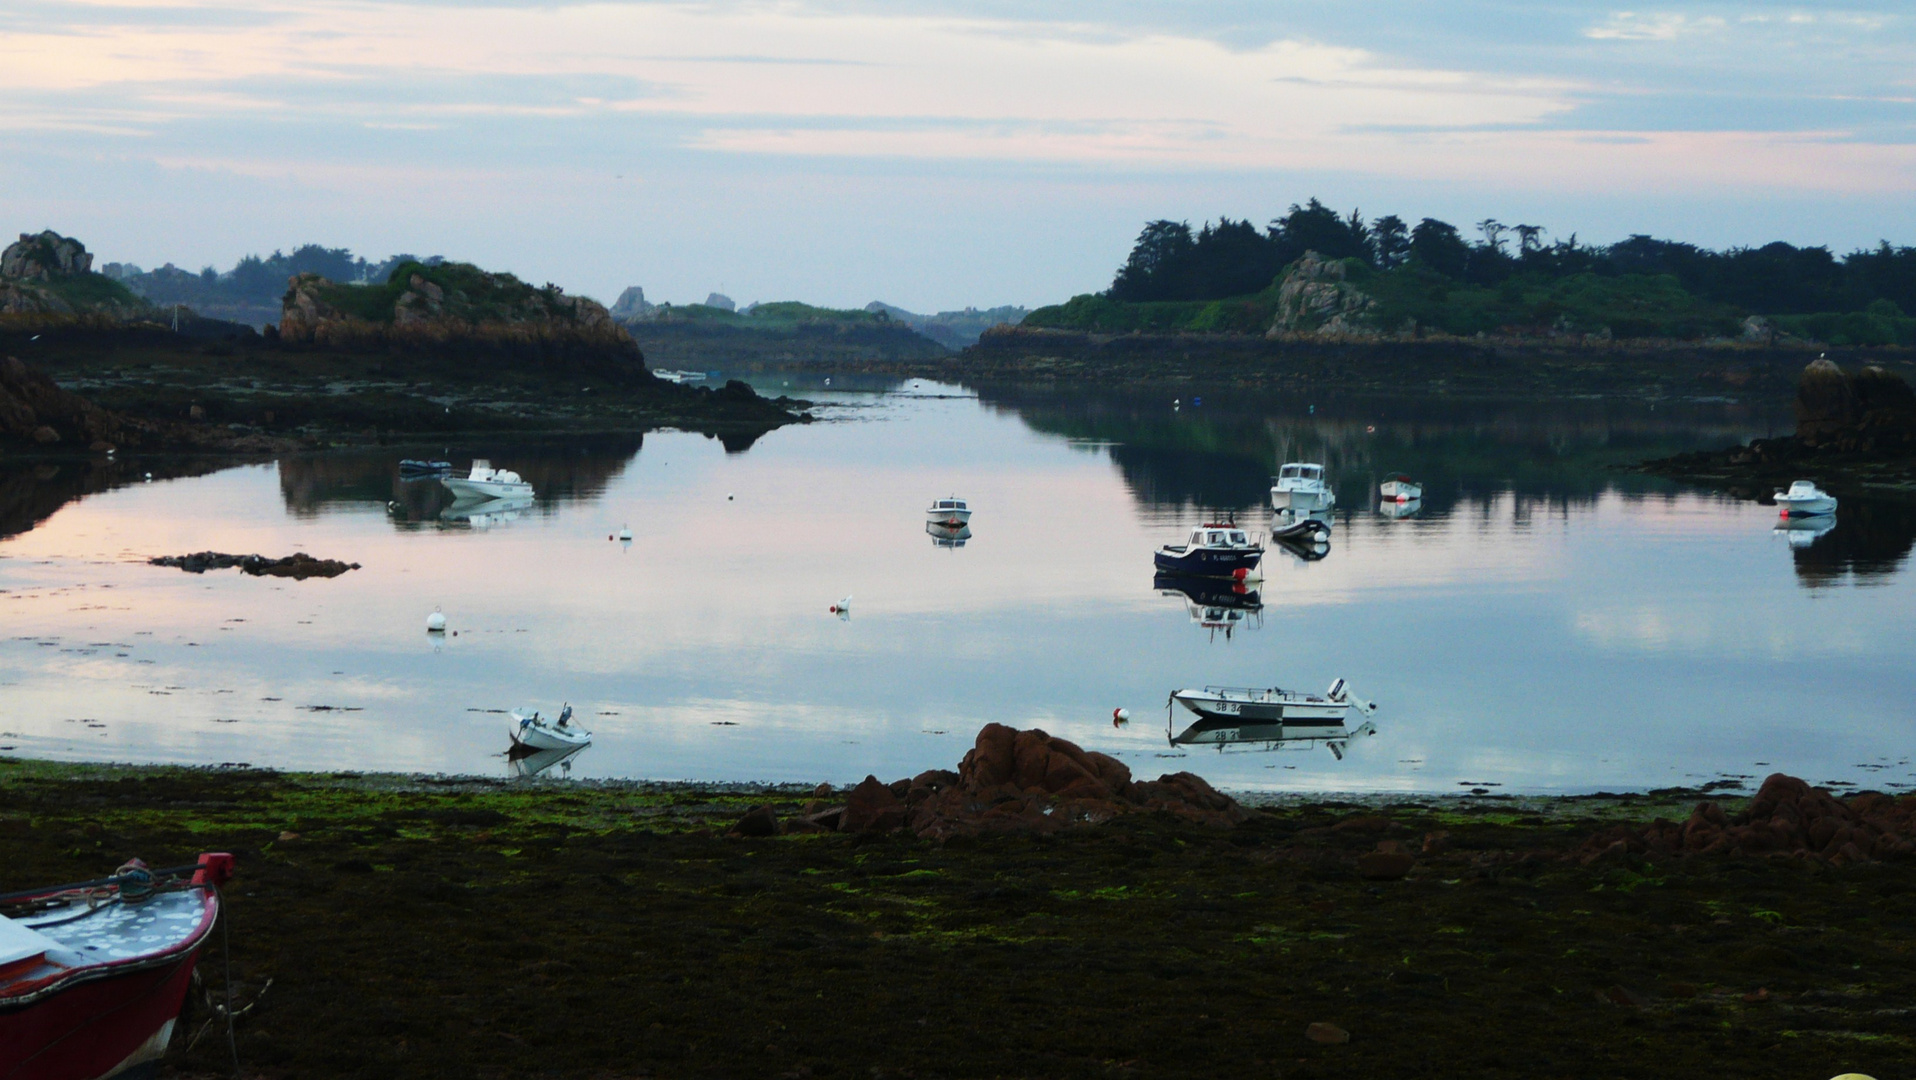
[734,724,1249,841]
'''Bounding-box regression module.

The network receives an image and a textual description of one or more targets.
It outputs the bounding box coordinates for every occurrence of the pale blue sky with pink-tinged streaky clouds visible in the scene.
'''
[0,0,1916,310]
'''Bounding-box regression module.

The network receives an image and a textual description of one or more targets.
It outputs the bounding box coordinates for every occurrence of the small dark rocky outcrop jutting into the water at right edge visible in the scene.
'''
[1642,356,1916,500]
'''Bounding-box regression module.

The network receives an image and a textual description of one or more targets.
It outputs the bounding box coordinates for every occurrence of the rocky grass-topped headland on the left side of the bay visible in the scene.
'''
[0,232,805,452]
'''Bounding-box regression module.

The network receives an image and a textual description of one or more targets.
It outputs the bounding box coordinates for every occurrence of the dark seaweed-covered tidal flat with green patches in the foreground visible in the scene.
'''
[0,758,1916,1078]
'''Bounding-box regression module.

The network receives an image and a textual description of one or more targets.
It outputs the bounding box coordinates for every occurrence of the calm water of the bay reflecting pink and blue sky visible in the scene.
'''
[0,375,1916,791]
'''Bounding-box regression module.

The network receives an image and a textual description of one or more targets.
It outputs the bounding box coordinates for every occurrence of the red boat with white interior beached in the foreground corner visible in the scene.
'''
[0,854,234,1080]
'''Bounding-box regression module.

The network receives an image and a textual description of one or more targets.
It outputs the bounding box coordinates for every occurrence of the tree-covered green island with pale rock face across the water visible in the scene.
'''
[1021,199,1916,347]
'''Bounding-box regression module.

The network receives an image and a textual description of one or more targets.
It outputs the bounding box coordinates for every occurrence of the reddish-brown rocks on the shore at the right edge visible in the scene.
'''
[1577,774,1916,866]
